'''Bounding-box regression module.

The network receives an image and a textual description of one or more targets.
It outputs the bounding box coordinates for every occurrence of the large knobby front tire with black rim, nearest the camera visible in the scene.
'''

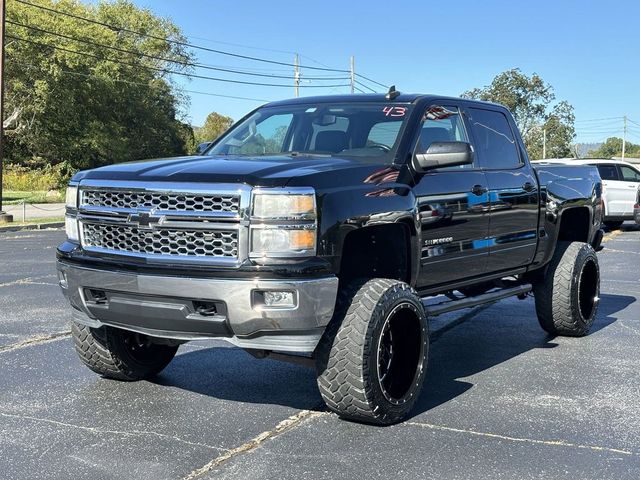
[315,279,429,425]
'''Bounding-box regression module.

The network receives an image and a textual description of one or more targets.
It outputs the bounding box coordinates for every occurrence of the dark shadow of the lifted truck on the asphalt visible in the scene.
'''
[155,294,636,416]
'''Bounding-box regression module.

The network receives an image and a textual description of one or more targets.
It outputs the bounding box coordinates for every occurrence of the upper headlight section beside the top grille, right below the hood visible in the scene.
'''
[253,193,316,220]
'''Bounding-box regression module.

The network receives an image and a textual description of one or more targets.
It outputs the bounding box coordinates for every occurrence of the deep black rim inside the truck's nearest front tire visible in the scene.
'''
[376,302,427,405]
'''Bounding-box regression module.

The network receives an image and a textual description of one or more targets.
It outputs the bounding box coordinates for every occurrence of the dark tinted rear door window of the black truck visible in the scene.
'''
[469,108,521,169]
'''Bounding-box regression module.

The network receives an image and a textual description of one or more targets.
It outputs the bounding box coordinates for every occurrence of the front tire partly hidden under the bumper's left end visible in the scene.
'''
[71,323,178,381]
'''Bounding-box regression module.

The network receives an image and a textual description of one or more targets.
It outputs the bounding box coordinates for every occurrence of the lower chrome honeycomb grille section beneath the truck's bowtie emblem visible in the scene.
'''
[81,222,238,258]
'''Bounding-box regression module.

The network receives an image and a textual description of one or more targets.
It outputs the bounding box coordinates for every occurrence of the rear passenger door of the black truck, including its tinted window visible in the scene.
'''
[468,107,539,272]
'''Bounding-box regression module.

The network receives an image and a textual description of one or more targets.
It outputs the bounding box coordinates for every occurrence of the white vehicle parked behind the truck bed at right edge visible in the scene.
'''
[536,159,640,230]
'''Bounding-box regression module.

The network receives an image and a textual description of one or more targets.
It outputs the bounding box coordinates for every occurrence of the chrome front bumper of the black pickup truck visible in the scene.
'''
[57,261,338,353]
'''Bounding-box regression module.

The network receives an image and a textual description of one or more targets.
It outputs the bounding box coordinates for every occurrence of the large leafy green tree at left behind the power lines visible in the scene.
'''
[5,0,193,169]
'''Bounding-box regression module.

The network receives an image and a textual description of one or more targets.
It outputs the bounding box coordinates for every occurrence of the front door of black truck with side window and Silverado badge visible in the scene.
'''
[414,104,489,288]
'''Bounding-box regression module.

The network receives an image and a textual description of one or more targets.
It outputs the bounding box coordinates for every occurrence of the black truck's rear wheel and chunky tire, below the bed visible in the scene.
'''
[533,242,600,337]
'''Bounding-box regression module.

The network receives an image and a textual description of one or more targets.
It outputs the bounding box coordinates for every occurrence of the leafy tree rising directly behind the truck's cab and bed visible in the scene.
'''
[462,68,575,159]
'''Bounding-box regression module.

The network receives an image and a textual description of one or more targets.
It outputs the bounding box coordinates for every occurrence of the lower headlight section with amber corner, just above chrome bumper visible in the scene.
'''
[251,227,316,257]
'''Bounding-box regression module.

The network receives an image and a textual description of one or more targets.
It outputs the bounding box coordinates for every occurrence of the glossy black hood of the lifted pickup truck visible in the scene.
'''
[74,155,390,187]
